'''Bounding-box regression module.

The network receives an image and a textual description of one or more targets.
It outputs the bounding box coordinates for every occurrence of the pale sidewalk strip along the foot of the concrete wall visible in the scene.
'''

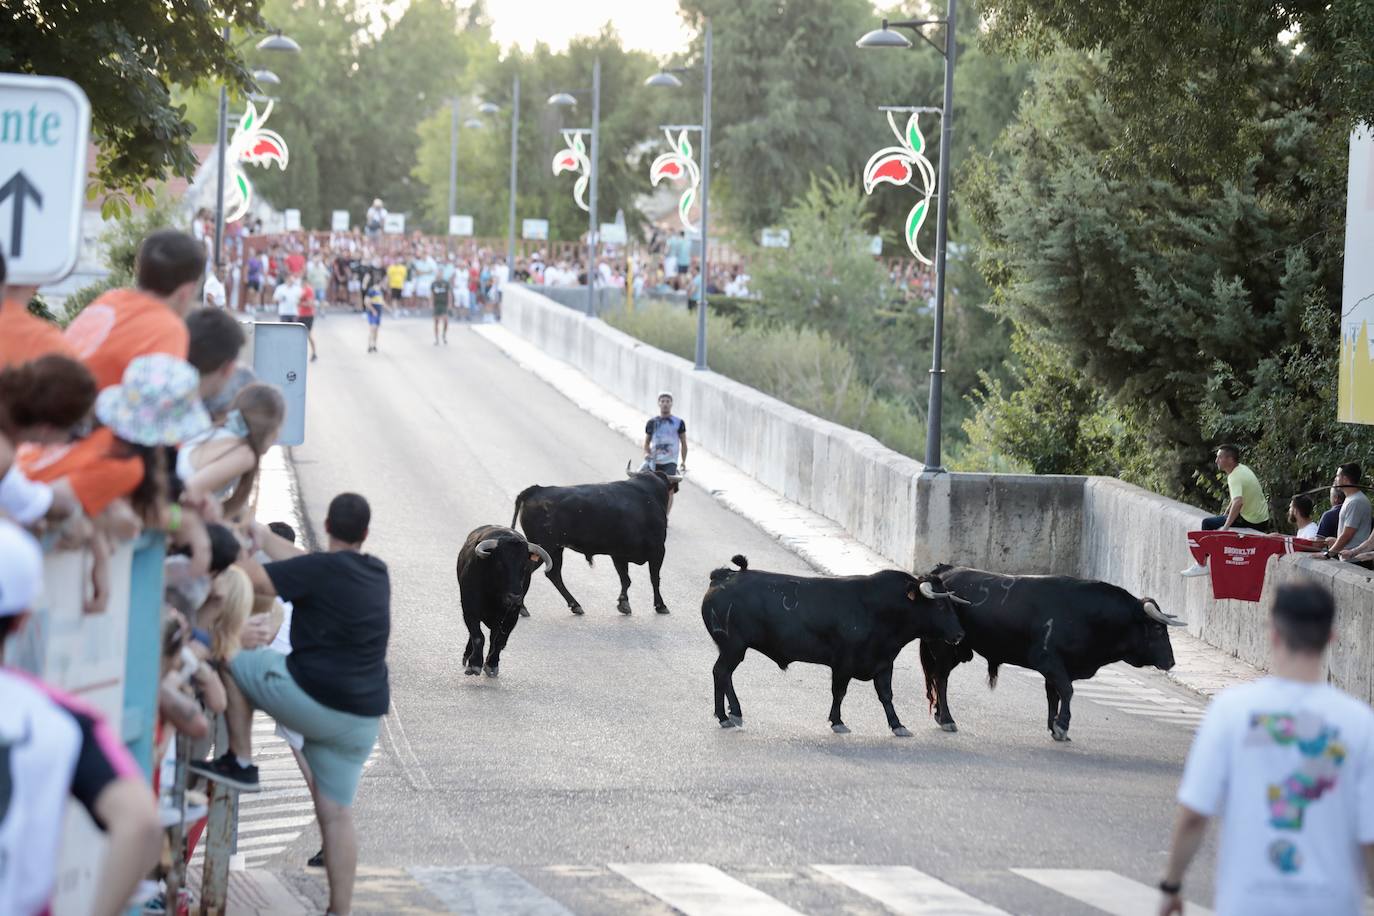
[473,324,1264,699]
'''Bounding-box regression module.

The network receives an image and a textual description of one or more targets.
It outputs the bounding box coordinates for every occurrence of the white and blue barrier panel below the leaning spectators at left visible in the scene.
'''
[4,534,166,913]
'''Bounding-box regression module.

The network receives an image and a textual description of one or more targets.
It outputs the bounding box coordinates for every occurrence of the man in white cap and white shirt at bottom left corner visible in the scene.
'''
[0,520,162,916]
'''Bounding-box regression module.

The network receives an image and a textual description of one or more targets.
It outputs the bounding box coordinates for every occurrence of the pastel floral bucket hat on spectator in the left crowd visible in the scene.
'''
[95,353,210,446]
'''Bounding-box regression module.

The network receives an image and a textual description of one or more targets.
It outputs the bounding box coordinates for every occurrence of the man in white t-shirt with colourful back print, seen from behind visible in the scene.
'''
[1160,584,1374,916]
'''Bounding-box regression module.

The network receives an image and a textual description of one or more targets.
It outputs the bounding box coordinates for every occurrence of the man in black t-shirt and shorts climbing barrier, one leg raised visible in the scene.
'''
[191,493,392,913]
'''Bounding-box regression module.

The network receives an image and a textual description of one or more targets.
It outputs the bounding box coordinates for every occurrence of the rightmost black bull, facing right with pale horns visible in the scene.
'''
[921,566,1186,742]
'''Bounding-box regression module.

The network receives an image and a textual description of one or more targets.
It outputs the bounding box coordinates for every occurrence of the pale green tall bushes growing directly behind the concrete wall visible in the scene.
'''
[602,305,926,460]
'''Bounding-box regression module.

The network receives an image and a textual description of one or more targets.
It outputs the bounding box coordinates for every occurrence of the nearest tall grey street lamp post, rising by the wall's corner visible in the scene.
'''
[856,0,958,474]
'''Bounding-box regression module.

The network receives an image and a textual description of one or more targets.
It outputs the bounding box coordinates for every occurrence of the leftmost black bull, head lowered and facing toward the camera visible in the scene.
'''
[458,525,550,677]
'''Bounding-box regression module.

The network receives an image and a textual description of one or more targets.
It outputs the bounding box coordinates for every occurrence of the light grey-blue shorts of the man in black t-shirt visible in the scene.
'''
[229,648,382,806]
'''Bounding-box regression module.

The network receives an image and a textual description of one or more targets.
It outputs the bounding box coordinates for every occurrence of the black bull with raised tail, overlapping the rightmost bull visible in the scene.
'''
[701,556,963,737]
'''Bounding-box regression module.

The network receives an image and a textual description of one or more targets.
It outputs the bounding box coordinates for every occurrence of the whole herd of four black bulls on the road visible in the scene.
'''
[458,471,1184,742]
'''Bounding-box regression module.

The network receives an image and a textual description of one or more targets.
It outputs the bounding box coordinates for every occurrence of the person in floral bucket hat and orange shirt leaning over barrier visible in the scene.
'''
[23,353,210,569]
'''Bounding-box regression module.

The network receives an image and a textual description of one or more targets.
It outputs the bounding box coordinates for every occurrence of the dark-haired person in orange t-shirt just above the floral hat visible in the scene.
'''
[66,229,205,389]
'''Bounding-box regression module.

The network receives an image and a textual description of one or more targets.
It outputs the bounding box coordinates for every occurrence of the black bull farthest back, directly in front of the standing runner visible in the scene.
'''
[511,470,680,614]
